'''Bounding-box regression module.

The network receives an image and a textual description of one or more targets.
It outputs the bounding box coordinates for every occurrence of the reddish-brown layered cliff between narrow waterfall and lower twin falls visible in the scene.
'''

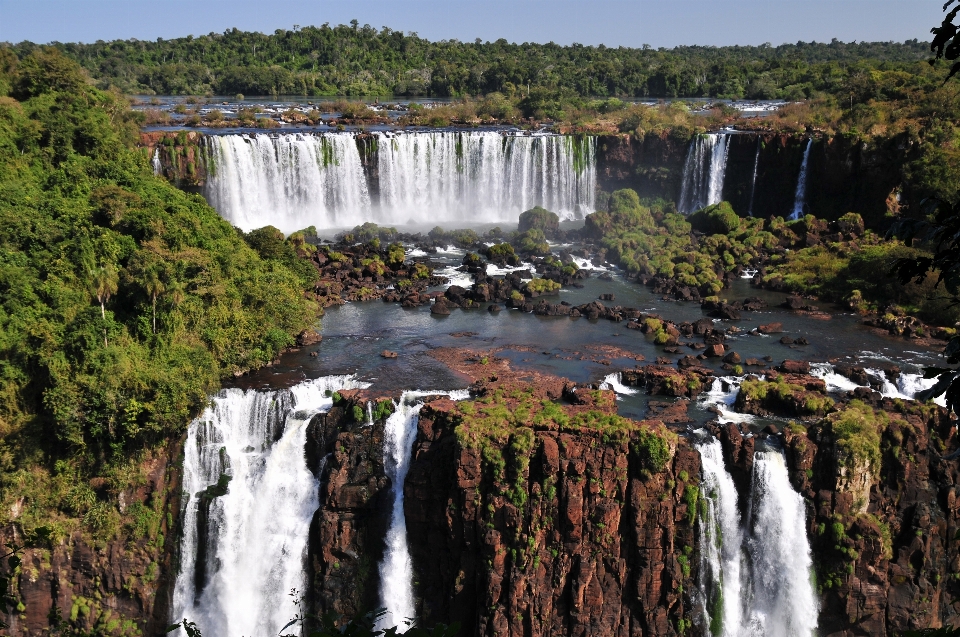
[405,392,700,636]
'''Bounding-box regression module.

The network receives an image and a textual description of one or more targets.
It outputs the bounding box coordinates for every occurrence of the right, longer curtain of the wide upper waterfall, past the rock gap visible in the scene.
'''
[377,132,596,224]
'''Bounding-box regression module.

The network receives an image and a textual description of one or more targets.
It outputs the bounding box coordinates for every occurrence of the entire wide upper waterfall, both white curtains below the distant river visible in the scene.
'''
[204,131,597,233]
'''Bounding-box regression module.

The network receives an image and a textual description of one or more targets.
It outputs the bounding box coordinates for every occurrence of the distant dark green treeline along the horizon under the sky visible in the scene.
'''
[5,21,941,100]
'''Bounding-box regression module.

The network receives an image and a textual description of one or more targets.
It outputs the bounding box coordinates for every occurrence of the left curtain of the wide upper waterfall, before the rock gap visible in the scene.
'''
[204,133,370,232]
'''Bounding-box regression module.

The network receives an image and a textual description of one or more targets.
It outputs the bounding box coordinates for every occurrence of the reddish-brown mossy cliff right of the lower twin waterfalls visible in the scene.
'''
[715,391,960,637]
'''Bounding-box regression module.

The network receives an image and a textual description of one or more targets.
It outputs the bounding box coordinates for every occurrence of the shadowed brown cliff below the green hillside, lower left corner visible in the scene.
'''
[0,444,180,637]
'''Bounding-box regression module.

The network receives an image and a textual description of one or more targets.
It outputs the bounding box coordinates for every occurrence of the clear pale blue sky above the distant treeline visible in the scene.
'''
[0,0,943,47]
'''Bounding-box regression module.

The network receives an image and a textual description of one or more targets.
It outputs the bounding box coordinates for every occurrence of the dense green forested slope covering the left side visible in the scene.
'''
[0,49,317,541]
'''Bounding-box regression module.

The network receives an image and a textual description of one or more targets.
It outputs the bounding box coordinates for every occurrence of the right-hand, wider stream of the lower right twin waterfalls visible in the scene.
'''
[738,451,819,637]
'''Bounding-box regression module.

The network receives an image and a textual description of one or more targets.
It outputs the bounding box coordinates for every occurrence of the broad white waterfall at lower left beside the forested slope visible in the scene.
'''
[172,376,367,637]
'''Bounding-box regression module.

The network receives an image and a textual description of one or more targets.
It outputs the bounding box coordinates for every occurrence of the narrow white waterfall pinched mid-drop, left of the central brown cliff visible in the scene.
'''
[379,390,469,628]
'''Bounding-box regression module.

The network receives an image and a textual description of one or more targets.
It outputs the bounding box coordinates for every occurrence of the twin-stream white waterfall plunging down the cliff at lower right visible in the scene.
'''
[697,436,819,637]
